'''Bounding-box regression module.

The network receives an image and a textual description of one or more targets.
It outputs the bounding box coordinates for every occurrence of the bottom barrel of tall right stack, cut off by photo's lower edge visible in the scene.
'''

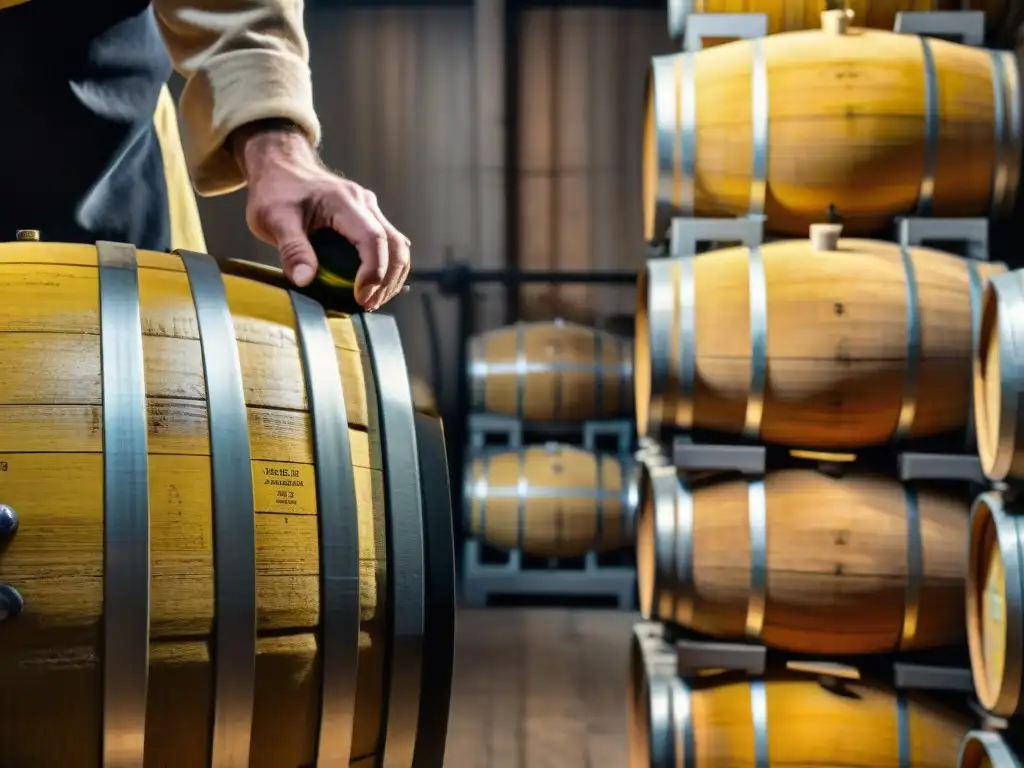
[629,624,971,768]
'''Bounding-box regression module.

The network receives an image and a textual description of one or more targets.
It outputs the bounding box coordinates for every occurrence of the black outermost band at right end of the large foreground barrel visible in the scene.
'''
[413,414,456,768]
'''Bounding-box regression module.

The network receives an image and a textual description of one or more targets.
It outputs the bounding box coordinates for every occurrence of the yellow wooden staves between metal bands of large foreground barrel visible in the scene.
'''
[0,243,387,768]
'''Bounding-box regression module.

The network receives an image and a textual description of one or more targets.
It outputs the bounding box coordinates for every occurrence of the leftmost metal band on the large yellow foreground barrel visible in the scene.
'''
[96,242,150,768]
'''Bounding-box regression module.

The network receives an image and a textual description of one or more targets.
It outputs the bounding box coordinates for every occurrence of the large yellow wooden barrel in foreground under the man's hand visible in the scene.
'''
[0,242,453,768]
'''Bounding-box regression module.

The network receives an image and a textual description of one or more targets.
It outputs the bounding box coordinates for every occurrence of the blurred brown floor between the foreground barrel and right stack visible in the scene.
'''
[444,608,637,768]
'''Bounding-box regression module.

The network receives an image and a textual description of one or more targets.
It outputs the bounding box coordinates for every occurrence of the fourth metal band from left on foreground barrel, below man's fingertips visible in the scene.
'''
[352,314,426,766]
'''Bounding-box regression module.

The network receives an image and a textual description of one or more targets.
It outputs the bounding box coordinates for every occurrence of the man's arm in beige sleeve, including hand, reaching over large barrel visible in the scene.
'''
[154,0,409,309]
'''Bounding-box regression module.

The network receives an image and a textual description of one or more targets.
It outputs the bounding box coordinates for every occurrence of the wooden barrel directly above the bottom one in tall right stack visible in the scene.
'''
[636,468,968,653]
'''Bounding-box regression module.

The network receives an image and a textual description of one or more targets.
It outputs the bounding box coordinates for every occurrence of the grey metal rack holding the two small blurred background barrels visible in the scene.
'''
[462,414,636,610]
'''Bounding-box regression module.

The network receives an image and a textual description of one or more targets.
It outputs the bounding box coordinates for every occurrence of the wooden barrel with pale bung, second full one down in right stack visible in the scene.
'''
[633,240,1006,449]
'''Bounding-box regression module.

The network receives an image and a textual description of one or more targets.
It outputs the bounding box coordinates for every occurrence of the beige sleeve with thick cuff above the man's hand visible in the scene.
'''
[153,0,321,196]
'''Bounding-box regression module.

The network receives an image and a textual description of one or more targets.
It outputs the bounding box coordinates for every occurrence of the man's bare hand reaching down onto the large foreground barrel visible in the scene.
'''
[230,121,411,309]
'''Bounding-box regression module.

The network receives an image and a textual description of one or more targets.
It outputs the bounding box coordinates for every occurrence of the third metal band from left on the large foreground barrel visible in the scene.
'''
[289,291,360,768]
